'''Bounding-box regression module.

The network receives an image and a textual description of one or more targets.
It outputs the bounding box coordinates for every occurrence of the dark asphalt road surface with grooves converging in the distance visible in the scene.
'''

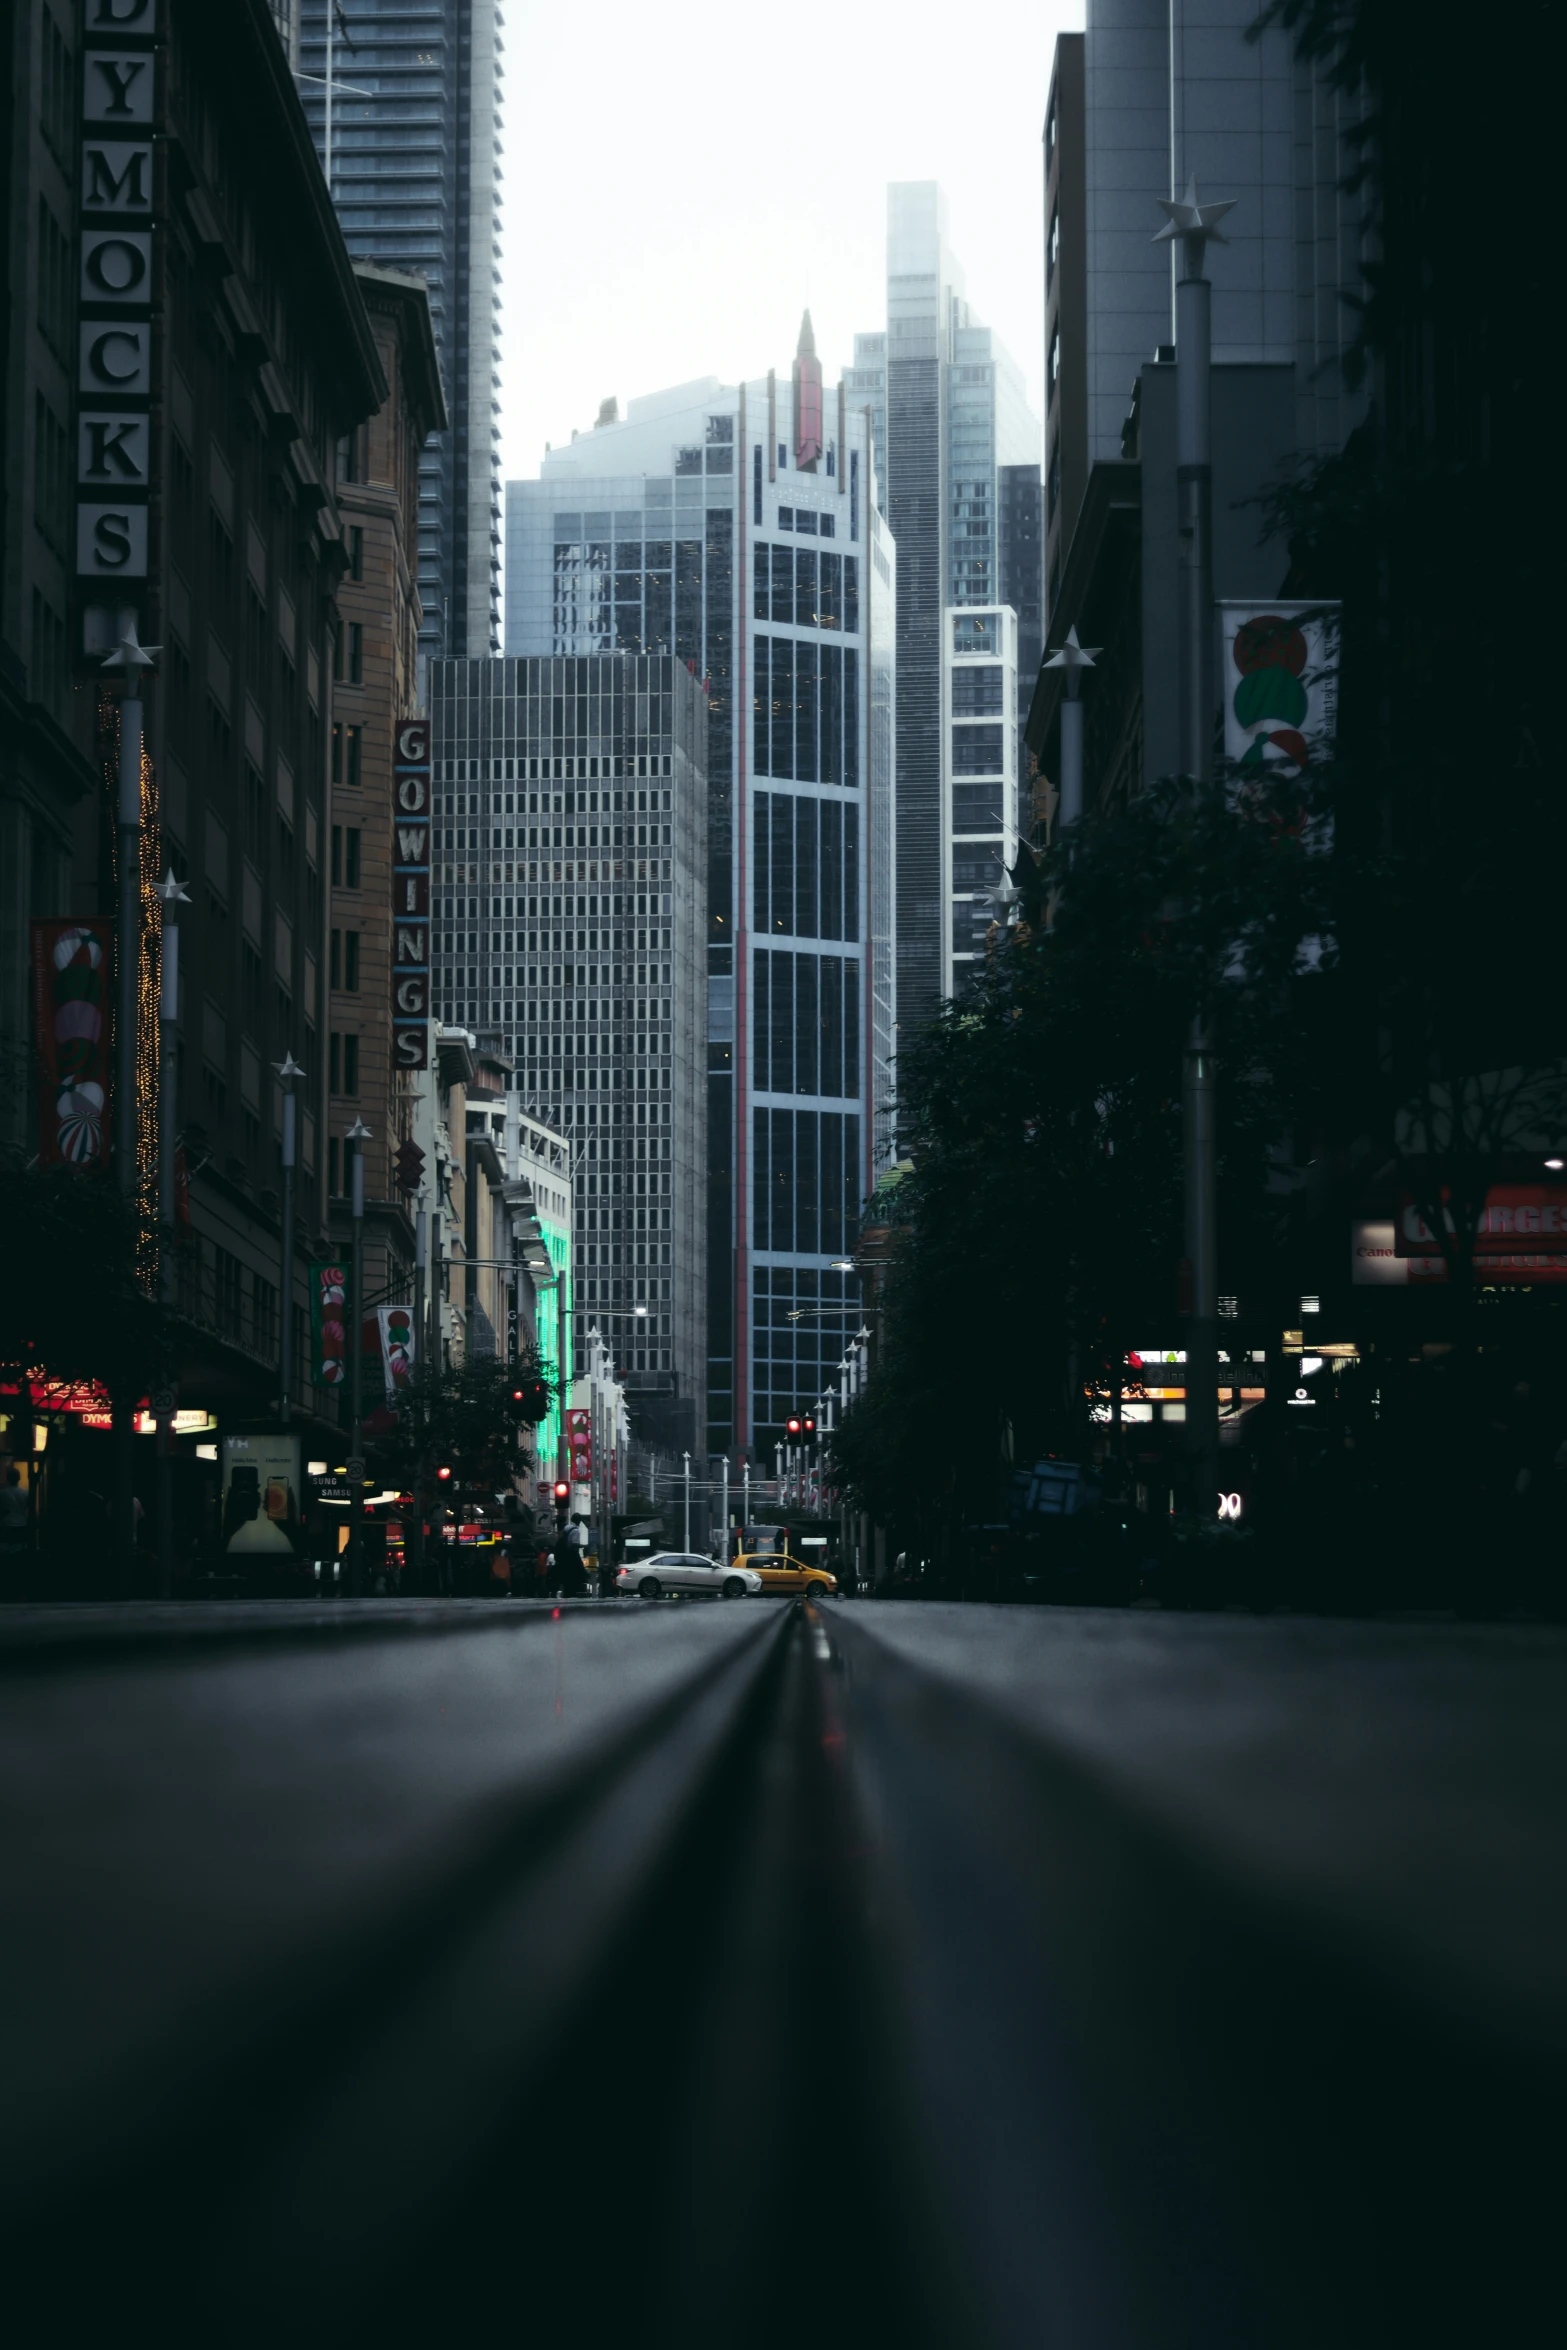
[0,1600,1567,2350]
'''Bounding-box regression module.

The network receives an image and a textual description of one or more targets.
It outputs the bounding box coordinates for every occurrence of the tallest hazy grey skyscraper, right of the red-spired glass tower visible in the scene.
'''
[848,181,1041,1032]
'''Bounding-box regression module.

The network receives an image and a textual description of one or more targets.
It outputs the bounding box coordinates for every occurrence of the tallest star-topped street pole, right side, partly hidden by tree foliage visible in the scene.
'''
[1154,179,1233,1518]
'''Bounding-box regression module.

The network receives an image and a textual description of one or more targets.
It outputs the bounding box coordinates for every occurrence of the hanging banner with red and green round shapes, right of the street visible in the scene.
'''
[1219,602,1339,773]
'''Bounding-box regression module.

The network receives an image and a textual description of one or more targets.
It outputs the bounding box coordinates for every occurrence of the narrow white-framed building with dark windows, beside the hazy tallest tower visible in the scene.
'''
[942,604,1017,996]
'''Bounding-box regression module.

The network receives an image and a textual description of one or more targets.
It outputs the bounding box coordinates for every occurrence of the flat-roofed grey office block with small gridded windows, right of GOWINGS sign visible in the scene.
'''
[430,653,707,1450]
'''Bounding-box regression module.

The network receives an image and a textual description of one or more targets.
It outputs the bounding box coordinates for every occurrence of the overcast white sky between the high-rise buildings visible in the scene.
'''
[500,0,1083,479]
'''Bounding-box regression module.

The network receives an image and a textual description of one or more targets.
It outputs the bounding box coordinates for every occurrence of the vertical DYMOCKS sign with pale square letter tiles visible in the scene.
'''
[75,0,160,585]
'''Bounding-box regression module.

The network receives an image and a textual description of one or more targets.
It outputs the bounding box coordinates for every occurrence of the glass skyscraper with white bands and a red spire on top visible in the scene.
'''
[505,338,895,1457]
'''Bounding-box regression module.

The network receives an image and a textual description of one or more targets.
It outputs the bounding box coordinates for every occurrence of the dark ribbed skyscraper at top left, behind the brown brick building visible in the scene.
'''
[294,0,503,658]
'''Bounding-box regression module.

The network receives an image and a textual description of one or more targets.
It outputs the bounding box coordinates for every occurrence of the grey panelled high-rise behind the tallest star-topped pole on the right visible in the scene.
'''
[1043,0,1363,804]
